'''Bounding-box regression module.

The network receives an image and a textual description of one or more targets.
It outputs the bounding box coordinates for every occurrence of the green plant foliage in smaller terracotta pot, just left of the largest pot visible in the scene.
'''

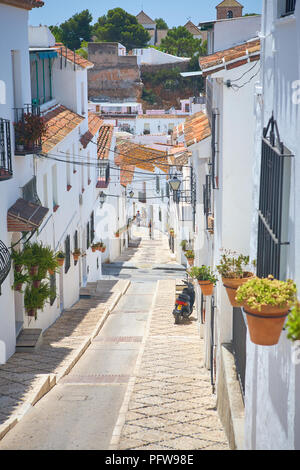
[217,250,254,279]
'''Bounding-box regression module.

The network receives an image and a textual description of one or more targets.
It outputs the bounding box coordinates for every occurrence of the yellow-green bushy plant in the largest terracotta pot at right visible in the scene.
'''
[236,276,297,312]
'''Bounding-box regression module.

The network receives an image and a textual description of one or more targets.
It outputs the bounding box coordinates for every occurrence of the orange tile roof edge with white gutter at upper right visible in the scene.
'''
[199,39,260,76]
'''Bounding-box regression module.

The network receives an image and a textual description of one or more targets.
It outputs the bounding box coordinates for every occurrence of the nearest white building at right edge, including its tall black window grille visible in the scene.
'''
[245,0,300,450]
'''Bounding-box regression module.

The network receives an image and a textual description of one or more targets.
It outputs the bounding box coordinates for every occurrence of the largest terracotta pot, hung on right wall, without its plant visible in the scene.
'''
[244,304,289,346]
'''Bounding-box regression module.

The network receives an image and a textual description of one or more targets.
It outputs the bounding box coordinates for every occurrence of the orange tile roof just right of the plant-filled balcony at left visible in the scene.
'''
[42,105,84,153]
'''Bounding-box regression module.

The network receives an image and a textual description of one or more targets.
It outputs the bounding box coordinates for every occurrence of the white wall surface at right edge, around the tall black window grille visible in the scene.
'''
[245,0,300,450]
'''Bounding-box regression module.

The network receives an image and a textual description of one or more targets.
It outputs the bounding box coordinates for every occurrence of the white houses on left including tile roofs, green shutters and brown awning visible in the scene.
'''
[0,15,125,363]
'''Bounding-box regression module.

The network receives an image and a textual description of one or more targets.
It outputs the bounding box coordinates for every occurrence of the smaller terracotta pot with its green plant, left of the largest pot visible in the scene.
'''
[217,250,254,307]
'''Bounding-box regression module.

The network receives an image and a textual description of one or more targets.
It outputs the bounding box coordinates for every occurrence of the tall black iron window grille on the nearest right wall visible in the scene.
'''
[257,116,292,279]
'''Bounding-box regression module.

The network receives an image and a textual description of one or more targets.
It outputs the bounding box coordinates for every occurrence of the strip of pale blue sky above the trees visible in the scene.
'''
[29,0,262,27]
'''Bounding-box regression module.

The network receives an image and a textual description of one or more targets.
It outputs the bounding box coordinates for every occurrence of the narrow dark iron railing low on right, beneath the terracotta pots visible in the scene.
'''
[232,308,247,397]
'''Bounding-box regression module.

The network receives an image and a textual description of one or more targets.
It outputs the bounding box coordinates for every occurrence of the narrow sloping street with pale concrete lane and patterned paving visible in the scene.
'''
[0,229,228,450]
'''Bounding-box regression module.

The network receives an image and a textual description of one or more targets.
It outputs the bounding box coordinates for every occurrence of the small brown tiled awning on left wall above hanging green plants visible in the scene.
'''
[7,198,49,232]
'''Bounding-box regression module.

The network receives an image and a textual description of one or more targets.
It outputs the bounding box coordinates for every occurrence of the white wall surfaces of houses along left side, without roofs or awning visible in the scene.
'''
[0,20,126,363]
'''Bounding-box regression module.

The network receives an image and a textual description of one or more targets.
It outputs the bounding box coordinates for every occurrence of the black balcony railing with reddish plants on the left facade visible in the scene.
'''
[14,105,42,155]
